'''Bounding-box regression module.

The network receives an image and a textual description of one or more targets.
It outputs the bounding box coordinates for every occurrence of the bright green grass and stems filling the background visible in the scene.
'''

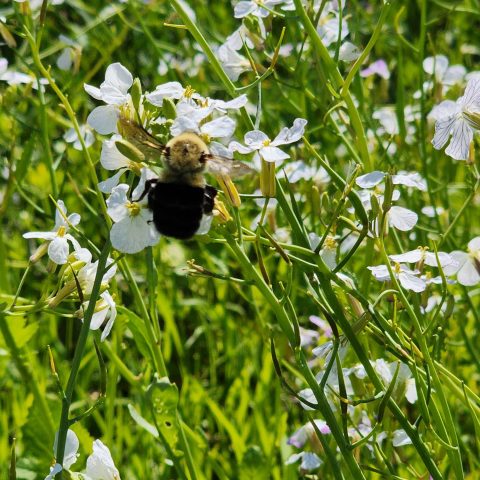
[0,0,480,480]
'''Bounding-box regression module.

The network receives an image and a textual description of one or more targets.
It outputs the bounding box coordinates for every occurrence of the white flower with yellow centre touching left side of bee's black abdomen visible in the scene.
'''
[107,168,160,253]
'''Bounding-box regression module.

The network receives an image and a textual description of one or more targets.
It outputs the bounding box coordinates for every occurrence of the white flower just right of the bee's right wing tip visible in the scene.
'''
[228,118,307,163]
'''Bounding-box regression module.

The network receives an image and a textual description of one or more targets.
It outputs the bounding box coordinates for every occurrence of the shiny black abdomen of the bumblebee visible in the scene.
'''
[148,182,205,240]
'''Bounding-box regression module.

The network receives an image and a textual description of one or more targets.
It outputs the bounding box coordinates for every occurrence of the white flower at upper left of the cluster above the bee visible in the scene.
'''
[84,63,133,135]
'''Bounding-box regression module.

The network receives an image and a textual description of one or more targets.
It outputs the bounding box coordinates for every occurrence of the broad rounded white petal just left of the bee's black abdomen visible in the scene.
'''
[110,215,160,253]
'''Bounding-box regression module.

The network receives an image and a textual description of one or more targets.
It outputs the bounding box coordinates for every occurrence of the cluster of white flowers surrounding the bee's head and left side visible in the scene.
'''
[85,63,307,253]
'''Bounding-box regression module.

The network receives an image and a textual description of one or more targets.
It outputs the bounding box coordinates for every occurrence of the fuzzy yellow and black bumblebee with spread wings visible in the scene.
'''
[119,117,253,240]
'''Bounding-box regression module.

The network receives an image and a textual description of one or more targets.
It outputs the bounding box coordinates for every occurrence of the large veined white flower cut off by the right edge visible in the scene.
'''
[432,78,480,160]
